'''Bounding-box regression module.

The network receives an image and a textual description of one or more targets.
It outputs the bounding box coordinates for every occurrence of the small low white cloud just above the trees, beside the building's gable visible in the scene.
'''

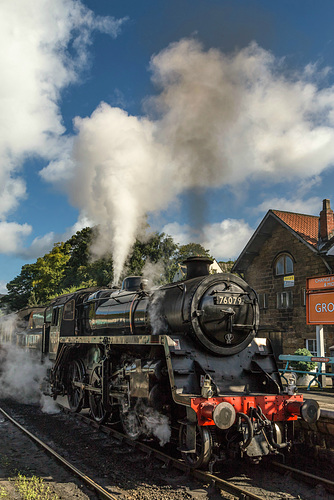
[162,219,253,260]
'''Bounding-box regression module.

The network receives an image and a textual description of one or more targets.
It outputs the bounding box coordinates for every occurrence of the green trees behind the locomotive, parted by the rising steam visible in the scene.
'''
[0,227,230,311]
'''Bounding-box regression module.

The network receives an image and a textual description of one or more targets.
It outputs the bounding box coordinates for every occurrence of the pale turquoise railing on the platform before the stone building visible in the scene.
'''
[279,354,334,391]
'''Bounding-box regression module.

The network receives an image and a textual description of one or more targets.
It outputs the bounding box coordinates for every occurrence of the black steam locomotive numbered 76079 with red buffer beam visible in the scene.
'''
[0,257,319,468]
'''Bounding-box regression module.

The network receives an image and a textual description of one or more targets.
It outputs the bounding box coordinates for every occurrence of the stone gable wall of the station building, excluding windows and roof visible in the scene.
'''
[245,225,334,355]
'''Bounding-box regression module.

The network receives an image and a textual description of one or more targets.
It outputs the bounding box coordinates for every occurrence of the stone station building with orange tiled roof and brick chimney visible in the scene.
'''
[232,200,334,356]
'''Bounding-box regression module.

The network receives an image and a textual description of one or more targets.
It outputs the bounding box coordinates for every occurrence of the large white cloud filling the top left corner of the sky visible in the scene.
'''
[0,0,124,253]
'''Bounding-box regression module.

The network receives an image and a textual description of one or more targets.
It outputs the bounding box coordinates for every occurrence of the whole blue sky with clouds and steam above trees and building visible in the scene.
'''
[0,0,334,293]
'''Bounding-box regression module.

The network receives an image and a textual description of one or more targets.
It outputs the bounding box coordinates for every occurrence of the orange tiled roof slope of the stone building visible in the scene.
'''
[272,210,319,247]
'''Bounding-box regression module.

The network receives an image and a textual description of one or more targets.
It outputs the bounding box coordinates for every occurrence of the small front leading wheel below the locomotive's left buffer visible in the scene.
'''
[179,424,212,469]
